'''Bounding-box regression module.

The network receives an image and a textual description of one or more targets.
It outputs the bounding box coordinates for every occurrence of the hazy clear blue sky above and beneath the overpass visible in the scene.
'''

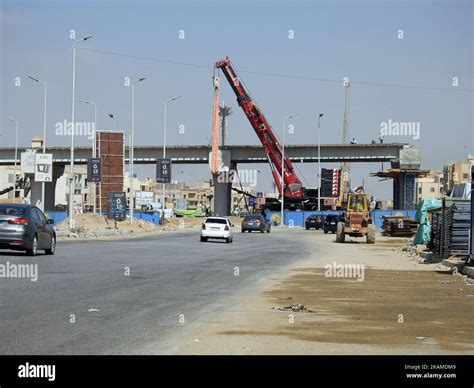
[0,0,474,197]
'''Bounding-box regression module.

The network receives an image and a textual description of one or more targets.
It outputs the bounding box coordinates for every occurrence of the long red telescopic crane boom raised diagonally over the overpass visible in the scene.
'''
[214,57,303,199]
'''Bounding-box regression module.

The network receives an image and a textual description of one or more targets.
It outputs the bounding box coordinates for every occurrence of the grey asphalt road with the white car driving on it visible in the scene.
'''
[0,229,314,354]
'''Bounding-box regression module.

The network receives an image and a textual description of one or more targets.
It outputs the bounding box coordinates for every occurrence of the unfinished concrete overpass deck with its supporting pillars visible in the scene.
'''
[0,143,415,215]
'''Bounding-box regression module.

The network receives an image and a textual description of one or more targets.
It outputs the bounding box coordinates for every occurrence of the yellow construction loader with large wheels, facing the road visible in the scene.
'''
[336,187,375,244]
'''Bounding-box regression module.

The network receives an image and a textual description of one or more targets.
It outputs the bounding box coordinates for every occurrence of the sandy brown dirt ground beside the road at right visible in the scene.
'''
[176,231,474,354]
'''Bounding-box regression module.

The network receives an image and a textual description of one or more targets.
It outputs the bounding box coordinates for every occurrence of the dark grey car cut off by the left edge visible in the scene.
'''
[0,204,56,256]
